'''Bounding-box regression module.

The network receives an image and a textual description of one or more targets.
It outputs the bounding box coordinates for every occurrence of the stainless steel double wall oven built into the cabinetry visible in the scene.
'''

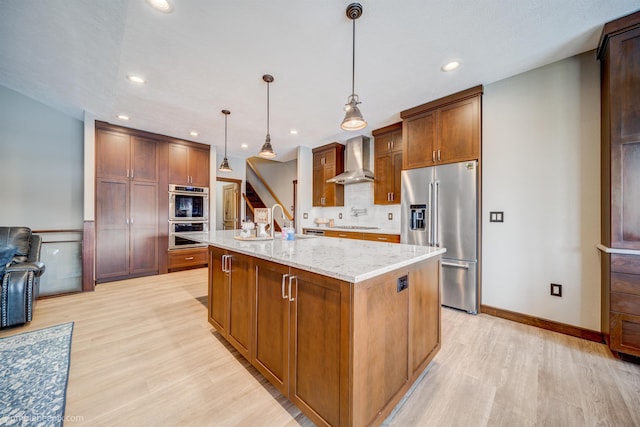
[169,184,209,250]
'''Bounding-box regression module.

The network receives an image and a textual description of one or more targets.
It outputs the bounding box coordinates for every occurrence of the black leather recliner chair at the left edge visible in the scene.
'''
[0,227,45,328]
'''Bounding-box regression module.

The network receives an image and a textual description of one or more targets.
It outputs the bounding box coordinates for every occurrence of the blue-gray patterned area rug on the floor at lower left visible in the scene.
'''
[0,322,73,426]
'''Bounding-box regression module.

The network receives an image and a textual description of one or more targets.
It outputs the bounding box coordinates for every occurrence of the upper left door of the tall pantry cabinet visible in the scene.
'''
[96,129,130,179]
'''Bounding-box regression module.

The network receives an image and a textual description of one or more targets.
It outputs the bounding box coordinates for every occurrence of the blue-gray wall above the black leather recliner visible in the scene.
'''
[0,86,84,230]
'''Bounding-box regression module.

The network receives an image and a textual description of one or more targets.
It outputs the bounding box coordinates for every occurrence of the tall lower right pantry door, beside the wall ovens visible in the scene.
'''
[129,181,158,274]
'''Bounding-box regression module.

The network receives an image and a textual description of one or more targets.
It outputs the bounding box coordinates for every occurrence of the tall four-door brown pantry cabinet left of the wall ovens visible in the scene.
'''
[95,128,159,282]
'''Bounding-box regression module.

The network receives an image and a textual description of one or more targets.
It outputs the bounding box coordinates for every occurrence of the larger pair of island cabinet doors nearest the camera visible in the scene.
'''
[252,260,349,425]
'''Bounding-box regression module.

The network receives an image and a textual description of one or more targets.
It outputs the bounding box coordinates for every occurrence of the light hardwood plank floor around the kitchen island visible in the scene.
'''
[0,269,640,427]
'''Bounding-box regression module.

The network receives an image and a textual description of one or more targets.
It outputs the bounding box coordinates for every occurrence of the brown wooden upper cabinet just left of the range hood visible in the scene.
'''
[313,142,344,206]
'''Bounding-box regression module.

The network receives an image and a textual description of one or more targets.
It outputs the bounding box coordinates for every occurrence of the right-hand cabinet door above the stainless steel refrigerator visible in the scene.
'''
[436,96,480,163]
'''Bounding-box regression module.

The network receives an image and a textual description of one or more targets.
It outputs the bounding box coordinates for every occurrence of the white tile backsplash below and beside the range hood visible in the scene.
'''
[301,182,400,234]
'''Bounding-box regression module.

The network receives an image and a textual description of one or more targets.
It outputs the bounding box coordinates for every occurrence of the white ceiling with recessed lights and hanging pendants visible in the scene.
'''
[0,0,639,160]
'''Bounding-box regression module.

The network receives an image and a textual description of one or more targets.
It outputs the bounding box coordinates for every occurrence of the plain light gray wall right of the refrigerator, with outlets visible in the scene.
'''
[482,51,600,331]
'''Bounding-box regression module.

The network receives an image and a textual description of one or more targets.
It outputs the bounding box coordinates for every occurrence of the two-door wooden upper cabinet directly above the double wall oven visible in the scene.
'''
[169,143,209,187]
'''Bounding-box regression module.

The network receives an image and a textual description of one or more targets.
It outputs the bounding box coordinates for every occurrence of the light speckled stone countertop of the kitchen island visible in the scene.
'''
[176,230,446,283]
